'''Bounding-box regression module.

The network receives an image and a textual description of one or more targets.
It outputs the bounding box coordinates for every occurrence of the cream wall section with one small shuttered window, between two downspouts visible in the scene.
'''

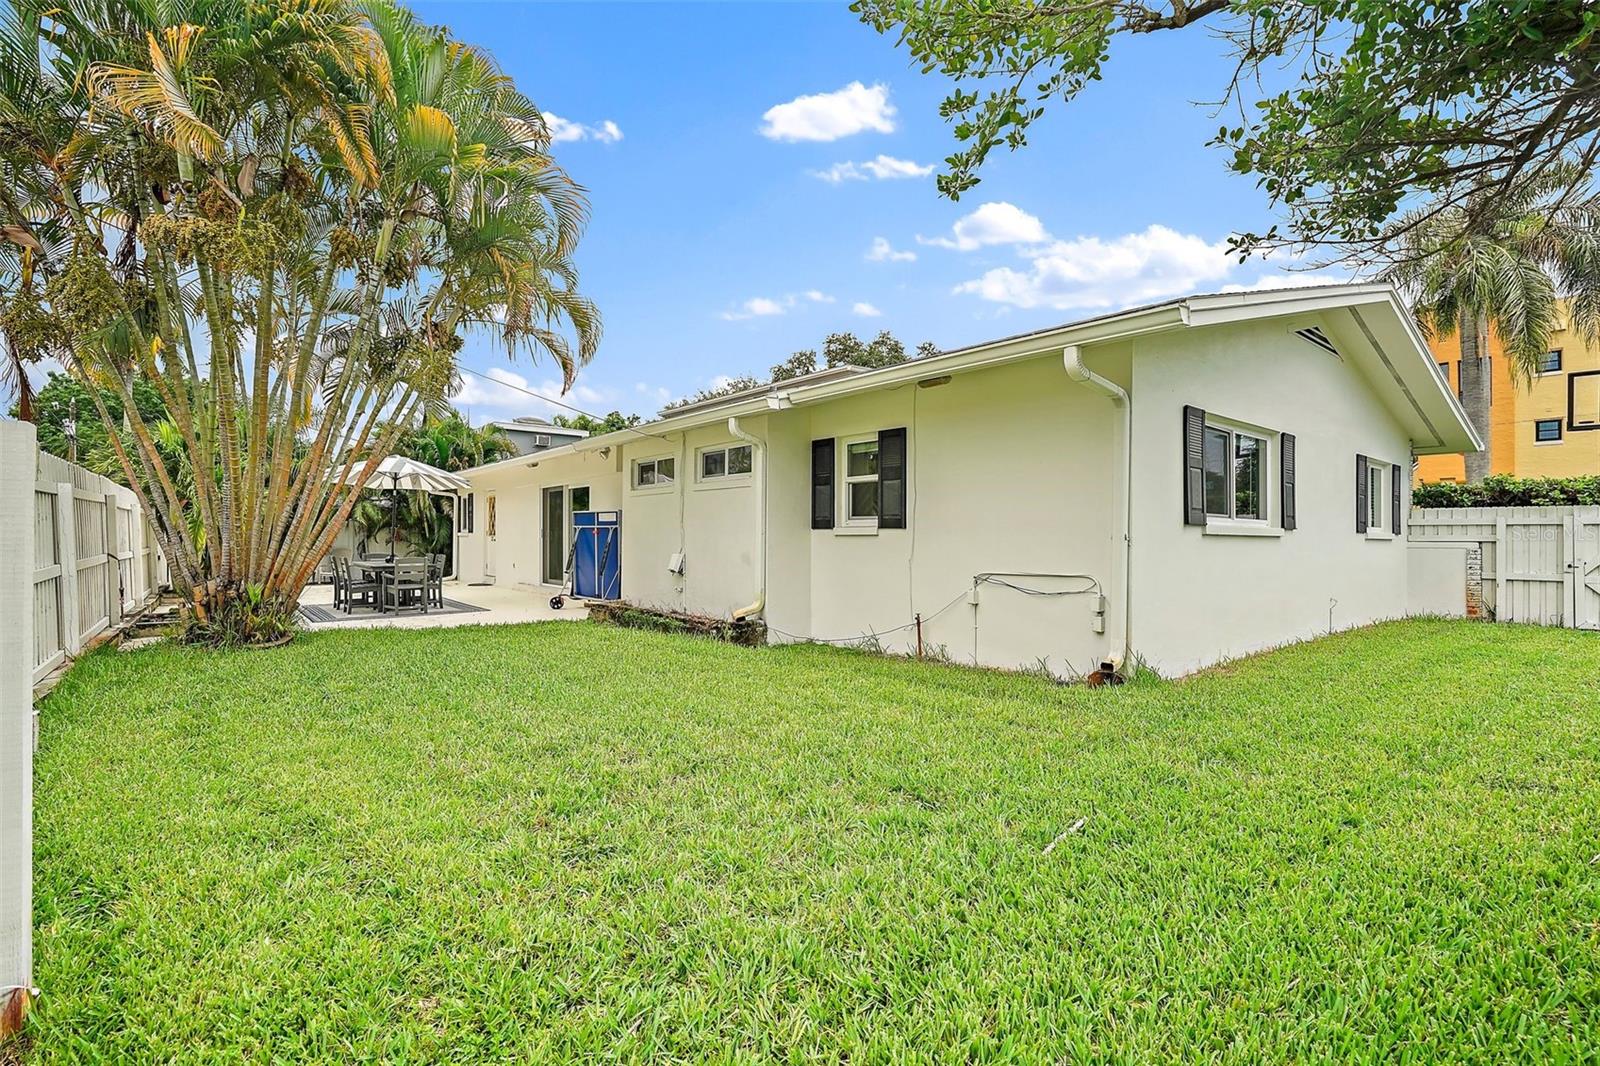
[768,357,1120,674]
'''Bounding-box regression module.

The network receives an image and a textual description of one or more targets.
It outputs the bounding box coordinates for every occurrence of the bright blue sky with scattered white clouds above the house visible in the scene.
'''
[418,3,1337,421]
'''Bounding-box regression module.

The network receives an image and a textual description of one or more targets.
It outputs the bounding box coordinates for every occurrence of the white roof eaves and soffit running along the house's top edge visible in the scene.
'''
[467,283,1483,475]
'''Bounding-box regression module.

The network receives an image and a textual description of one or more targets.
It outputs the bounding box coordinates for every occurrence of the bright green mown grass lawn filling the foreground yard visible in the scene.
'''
[12,623,1600,1063]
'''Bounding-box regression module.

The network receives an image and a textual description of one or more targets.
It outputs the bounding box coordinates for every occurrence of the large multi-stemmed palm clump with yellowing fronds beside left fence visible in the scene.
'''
[0,0,600,640]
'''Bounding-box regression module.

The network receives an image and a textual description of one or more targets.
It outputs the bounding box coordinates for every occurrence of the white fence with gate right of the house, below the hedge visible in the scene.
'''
[1408,507,1600,629]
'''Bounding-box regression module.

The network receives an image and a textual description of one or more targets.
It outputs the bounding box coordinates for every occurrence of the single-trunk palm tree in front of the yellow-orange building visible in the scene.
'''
[1386,171,1600,482]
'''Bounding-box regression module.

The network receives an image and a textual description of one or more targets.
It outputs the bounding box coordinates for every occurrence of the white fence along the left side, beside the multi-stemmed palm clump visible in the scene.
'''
[29,438,166,682]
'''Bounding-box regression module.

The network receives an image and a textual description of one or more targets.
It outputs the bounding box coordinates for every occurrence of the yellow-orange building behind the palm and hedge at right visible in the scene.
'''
[1416,307,1600,483]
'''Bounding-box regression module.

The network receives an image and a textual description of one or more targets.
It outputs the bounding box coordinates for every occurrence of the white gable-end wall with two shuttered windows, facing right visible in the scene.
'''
[1133,313,1411,674]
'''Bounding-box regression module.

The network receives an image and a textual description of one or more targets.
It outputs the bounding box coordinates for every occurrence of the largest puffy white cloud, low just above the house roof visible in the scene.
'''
[954,219,1235,311]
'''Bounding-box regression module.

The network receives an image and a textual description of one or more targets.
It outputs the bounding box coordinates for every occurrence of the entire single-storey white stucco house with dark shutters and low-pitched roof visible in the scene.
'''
[459,285,1480,675]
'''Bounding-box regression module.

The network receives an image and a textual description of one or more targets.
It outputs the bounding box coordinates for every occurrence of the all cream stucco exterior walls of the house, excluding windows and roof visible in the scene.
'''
[462,291,1466,675]
